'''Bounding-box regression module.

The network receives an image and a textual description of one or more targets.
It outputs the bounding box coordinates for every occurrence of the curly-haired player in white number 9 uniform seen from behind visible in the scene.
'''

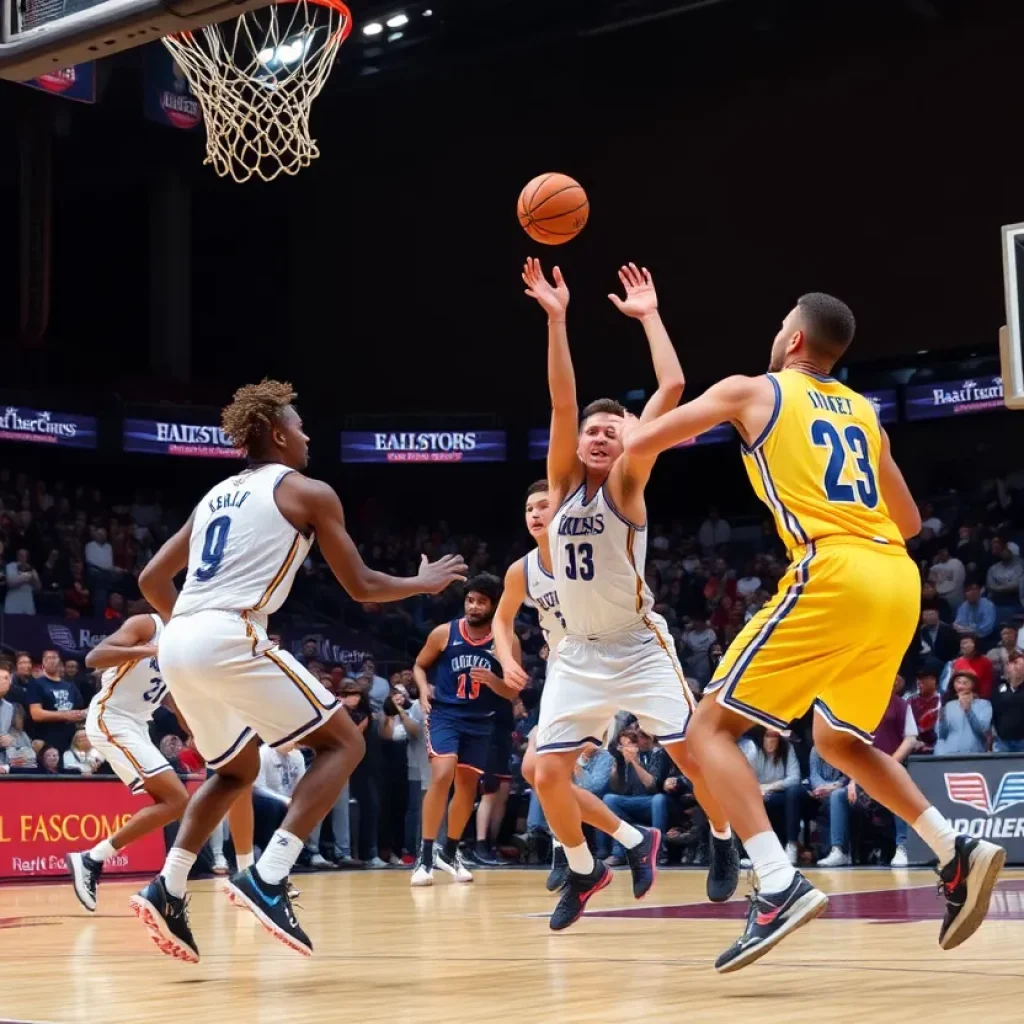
[131,380,466,963]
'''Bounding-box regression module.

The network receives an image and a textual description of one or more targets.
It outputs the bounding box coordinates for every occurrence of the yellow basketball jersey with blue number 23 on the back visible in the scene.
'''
[743,370,903,551]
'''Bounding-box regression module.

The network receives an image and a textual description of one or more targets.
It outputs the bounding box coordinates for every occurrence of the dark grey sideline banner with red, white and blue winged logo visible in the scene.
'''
[907,754,1024,864]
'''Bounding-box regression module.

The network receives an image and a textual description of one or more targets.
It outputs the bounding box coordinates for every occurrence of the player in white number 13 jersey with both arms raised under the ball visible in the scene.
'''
[520,259,739,930]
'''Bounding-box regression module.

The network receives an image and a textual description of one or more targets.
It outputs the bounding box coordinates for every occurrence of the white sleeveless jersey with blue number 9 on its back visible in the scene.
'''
[174,463,312,621]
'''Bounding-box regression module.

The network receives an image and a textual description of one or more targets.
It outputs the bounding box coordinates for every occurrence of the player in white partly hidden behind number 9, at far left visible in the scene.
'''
[65,615,188,910]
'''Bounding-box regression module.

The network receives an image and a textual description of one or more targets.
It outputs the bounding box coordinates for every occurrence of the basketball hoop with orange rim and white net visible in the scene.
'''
[163,0,352,182]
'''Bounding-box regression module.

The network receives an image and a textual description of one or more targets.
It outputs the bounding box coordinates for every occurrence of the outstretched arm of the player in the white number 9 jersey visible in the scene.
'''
[292,473,466,601]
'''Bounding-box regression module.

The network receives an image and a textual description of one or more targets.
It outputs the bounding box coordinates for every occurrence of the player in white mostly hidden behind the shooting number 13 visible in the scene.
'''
[494,480,656,899]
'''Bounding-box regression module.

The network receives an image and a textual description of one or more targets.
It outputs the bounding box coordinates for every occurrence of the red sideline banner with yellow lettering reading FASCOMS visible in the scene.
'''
[0,775,201,880]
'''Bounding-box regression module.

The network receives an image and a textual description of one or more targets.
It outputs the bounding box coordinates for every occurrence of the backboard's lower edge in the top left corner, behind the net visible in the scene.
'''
[0,0,272,82]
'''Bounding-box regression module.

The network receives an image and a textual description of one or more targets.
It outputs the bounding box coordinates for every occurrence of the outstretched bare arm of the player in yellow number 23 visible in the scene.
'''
[626,376,775,459]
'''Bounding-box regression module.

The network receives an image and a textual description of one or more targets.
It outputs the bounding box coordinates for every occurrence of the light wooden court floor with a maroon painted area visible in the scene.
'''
[0,870,1024,1024]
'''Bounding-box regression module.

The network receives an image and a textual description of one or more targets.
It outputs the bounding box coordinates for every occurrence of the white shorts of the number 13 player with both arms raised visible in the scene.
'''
[536,613,694,754]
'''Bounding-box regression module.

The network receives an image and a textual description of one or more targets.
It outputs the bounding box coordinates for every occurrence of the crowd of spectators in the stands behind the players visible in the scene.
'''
[0,470,1024,867]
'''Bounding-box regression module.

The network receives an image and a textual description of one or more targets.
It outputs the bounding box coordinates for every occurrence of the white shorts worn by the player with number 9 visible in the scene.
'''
[158,611,342,768]
